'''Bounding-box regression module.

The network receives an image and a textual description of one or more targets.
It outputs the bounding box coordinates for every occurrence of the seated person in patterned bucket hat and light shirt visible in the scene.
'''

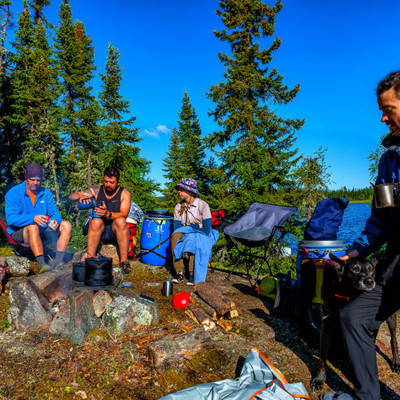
[171,178,216,285]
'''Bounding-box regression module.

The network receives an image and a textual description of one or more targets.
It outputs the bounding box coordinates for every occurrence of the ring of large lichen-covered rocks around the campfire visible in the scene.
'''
[8,268,160,344]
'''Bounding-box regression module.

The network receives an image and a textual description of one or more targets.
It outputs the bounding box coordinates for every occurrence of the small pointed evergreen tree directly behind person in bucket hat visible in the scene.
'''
[163,91,209,207]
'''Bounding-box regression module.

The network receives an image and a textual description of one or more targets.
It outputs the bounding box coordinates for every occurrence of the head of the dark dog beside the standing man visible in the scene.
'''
[329,254,376,290]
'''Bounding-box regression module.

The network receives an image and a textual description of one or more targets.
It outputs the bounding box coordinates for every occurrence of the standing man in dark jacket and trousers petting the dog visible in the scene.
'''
[321,71,400,400]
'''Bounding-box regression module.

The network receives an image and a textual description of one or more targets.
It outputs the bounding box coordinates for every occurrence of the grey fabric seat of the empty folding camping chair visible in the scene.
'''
[224,203,297,244]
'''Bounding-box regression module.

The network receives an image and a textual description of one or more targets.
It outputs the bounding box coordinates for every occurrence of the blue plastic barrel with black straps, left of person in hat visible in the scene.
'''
[140,210,174,266]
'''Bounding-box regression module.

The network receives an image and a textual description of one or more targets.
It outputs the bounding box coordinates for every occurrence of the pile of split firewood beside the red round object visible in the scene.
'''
[185,282,239,332]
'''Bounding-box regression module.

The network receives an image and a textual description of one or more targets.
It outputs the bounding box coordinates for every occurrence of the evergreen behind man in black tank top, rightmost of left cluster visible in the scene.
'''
[99,44,157,211]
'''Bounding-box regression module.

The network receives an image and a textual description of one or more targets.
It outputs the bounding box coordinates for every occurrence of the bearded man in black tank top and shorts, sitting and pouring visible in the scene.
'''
[69,167,131,273]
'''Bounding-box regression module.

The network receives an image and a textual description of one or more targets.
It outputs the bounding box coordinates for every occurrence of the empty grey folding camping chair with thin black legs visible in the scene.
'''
[224,203,297,288]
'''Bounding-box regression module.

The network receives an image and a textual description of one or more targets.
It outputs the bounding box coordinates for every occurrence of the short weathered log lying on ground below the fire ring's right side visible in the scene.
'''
[148,328,211,371]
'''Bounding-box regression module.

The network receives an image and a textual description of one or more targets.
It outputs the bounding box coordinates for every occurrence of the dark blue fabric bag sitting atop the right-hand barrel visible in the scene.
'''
[304,197,349,240]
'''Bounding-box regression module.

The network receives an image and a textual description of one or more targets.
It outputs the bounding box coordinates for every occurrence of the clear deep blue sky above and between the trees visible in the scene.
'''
[7,0,400,188]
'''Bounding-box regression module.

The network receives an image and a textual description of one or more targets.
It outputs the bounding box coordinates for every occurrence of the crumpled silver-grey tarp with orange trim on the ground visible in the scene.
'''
[159,347,310,400]
